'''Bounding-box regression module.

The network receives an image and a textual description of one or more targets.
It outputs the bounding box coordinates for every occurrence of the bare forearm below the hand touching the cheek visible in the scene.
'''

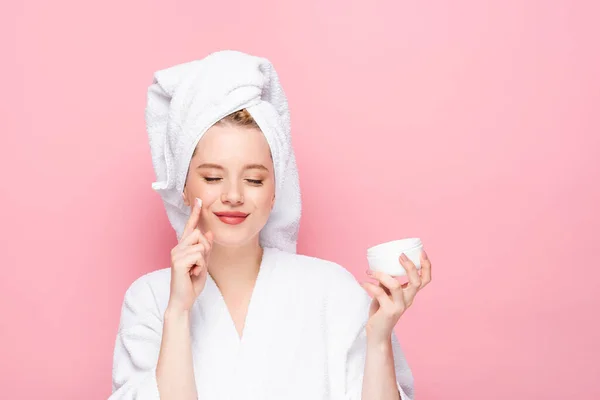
[156,308,198,400]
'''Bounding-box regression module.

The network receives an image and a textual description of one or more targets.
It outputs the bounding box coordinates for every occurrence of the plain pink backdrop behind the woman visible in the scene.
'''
[0,0,600,400]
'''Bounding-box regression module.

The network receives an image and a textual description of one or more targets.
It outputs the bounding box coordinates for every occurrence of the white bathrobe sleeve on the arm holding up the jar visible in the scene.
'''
[328,267,414,400]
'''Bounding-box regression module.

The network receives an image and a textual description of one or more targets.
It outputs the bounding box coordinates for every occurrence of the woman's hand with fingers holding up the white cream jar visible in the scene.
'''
[362,251,431,343]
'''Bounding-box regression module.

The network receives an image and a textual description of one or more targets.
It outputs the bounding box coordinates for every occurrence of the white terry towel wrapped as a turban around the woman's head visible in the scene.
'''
[146,50,301,253]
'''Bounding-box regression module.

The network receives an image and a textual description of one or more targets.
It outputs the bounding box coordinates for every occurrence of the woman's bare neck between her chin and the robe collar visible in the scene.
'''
[208,239,263,291]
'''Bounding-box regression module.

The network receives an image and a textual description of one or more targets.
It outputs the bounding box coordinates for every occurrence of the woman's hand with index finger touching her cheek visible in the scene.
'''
[168,199,213,312]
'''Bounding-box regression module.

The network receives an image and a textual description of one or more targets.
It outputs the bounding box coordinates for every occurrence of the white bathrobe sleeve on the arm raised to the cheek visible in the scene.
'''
[109,276,163,400]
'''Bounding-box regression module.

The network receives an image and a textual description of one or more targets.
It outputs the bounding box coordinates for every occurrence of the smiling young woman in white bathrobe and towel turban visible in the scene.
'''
[111,51,431,400]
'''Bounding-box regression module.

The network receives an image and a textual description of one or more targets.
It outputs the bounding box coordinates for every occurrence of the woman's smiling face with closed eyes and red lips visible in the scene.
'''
[183,125,275,246]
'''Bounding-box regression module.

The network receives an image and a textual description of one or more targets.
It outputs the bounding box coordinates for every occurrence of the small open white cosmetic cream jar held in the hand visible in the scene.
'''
[367,238,423,276]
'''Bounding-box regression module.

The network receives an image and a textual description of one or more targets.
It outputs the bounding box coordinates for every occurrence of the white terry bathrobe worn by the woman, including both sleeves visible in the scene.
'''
[110,248,413,400]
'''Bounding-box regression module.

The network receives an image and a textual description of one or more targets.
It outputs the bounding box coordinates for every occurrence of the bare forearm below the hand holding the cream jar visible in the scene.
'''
[362,339,400,400]
